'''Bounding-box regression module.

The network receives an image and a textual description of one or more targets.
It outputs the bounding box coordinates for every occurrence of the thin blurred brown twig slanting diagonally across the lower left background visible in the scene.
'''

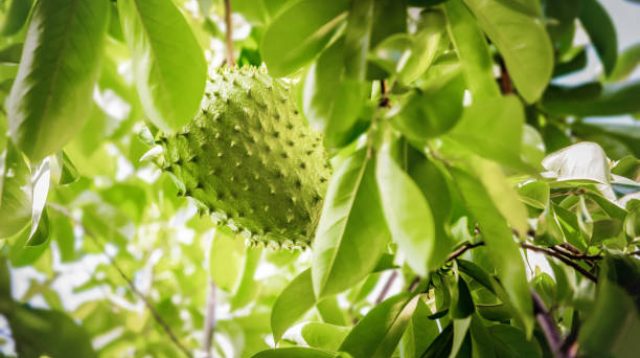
[47,203,191,357]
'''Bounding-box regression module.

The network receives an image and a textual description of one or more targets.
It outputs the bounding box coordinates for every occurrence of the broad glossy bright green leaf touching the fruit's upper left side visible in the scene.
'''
[118,0,207,131]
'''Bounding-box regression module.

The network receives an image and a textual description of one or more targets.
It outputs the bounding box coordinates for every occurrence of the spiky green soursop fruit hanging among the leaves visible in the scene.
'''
[156,67,330,248]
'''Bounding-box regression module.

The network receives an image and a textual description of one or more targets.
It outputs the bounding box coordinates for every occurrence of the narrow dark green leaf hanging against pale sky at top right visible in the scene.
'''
[580,0,618,75]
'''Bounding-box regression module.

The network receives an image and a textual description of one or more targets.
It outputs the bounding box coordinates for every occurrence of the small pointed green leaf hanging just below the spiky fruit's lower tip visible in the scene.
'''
[271,269,316,343]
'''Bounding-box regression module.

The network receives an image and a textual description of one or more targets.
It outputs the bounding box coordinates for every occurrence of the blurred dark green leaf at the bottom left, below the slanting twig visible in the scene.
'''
[6,305,97,358]
